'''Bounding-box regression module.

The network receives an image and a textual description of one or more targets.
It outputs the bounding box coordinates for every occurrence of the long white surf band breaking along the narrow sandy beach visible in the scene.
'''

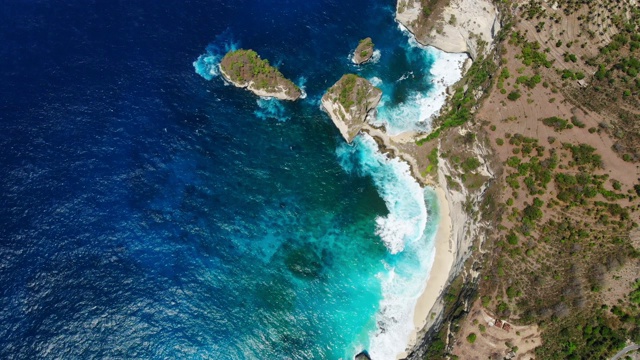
[336,134,437,360]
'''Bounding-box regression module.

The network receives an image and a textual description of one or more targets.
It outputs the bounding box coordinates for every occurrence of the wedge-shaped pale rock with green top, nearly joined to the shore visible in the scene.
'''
[322,74,382,143]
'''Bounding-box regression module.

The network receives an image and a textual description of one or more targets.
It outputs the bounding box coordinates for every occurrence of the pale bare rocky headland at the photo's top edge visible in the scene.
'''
[396,0,500,59]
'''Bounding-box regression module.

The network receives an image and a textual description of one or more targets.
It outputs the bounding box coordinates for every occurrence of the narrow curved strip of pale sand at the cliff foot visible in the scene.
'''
[398,187,456,359]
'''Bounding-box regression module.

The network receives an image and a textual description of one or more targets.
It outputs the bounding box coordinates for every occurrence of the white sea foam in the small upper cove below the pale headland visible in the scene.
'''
[368,27,468,135]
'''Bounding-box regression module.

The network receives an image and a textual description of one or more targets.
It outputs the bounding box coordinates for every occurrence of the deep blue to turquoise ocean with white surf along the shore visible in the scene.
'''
[0,0,456,360]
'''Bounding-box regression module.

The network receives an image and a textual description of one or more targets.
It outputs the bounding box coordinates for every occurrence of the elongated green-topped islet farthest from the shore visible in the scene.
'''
[220,49,302,101]
